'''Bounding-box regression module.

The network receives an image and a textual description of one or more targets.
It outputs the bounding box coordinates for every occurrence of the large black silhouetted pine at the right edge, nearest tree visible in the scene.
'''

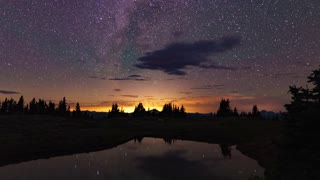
[275,68,320,179]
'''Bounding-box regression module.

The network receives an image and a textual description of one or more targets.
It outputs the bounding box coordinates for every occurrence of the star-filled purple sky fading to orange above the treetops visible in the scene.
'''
[0,0,320,113]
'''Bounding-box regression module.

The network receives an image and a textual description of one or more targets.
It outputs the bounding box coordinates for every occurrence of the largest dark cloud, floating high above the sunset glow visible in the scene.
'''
[135,37,240,76]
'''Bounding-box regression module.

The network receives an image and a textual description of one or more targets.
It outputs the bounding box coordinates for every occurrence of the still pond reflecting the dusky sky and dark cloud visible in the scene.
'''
[0,138,264,180]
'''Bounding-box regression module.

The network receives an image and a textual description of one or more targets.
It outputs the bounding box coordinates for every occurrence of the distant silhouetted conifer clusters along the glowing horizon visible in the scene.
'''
[0,96,260,118]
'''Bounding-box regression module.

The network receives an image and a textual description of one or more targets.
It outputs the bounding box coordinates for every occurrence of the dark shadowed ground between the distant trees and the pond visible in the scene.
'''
[0,115,316,179]
